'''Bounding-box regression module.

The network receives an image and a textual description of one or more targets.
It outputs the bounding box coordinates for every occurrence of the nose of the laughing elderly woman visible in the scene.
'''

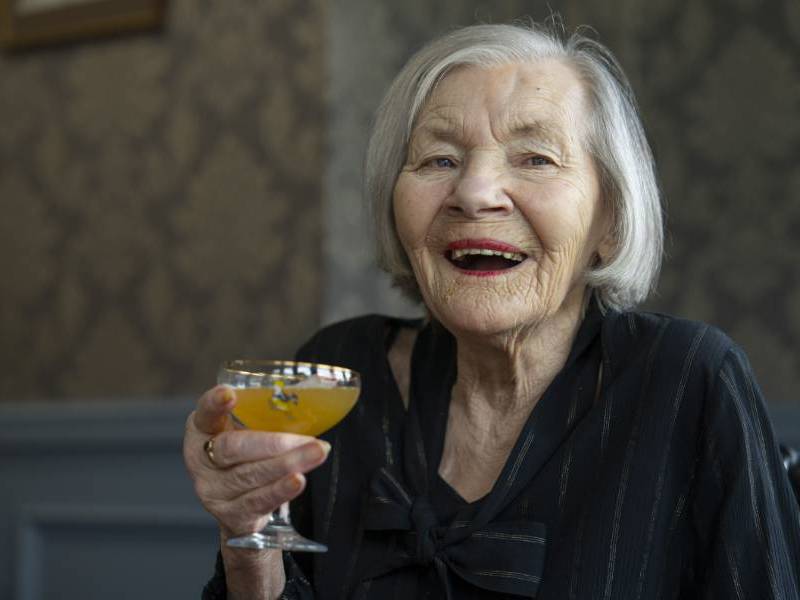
[446,164,514,219]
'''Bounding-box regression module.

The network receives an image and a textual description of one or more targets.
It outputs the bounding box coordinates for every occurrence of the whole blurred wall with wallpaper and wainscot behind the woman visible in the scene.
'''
[0,0,800,598]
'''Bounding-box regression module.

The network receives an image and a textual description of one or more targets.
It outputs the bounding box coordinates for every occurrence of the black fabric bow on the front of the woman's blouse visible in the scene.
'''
[364,468,546,598]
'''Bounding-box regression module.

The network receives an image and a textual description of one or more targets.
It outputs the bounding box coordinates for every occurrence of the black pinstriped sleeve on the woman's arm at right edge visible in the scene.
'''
[693,347,800,600]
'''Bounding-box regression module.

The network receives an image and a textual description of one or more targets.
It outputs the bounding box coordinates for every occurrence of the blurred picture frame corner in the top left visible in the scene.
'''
[0,0,166,49]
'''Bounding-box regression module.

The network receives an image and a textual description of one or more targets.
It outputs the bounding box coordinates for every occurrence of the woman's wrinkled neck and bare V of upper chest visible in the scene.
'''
[439,290,586,502]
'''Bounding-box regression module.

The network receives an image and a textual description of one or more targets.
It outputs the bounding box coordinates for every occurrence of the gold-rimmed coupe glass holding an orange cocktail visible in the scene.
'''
[217,360,361,552]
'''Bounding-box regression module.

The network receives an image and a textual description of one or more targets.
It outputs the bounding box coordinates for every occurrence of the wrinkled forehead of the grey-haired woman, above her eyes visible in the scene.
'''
[412,59,589,144]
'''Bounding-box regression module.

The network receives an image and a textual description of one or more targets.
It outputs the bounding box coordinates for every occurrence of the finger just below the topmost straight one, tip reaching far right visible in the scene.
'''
[220,440,330,498]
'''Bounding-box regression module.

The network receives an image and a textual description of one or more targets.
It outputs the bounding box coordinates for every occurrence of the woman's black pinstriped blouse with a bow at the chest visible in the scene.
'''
[204,304,800,600]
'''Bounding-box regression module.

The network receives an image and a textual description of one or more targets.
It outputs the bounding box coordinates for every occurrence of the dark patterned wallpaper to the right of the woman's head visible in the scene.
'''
[570,0,800,406]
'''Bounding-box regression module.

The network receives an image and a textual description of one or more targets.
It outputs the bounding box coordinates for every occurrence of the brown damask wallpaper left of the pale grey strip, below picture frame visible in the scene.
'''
[0,0,326,400]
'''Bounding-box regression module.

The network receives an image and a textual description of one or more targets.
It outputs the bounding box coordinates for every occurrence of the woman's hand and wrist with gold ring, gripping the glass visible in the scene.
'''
[183,386,330,598]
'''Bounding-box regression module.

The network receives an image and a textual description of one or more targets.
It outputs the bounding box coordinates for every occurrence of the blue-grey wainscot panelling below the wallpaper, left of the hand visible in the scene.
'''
[0,399,218,600]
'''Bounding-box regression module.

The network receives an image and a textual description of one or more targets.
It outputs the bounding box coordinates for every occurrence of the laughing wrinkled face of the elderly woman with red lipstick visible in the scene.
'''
[394,60,612,334]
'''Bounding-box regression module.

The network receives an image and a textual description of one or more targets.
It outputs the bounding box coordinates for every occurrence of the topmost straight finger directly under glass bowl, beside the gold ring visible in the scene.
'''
[214,429,330,468]
